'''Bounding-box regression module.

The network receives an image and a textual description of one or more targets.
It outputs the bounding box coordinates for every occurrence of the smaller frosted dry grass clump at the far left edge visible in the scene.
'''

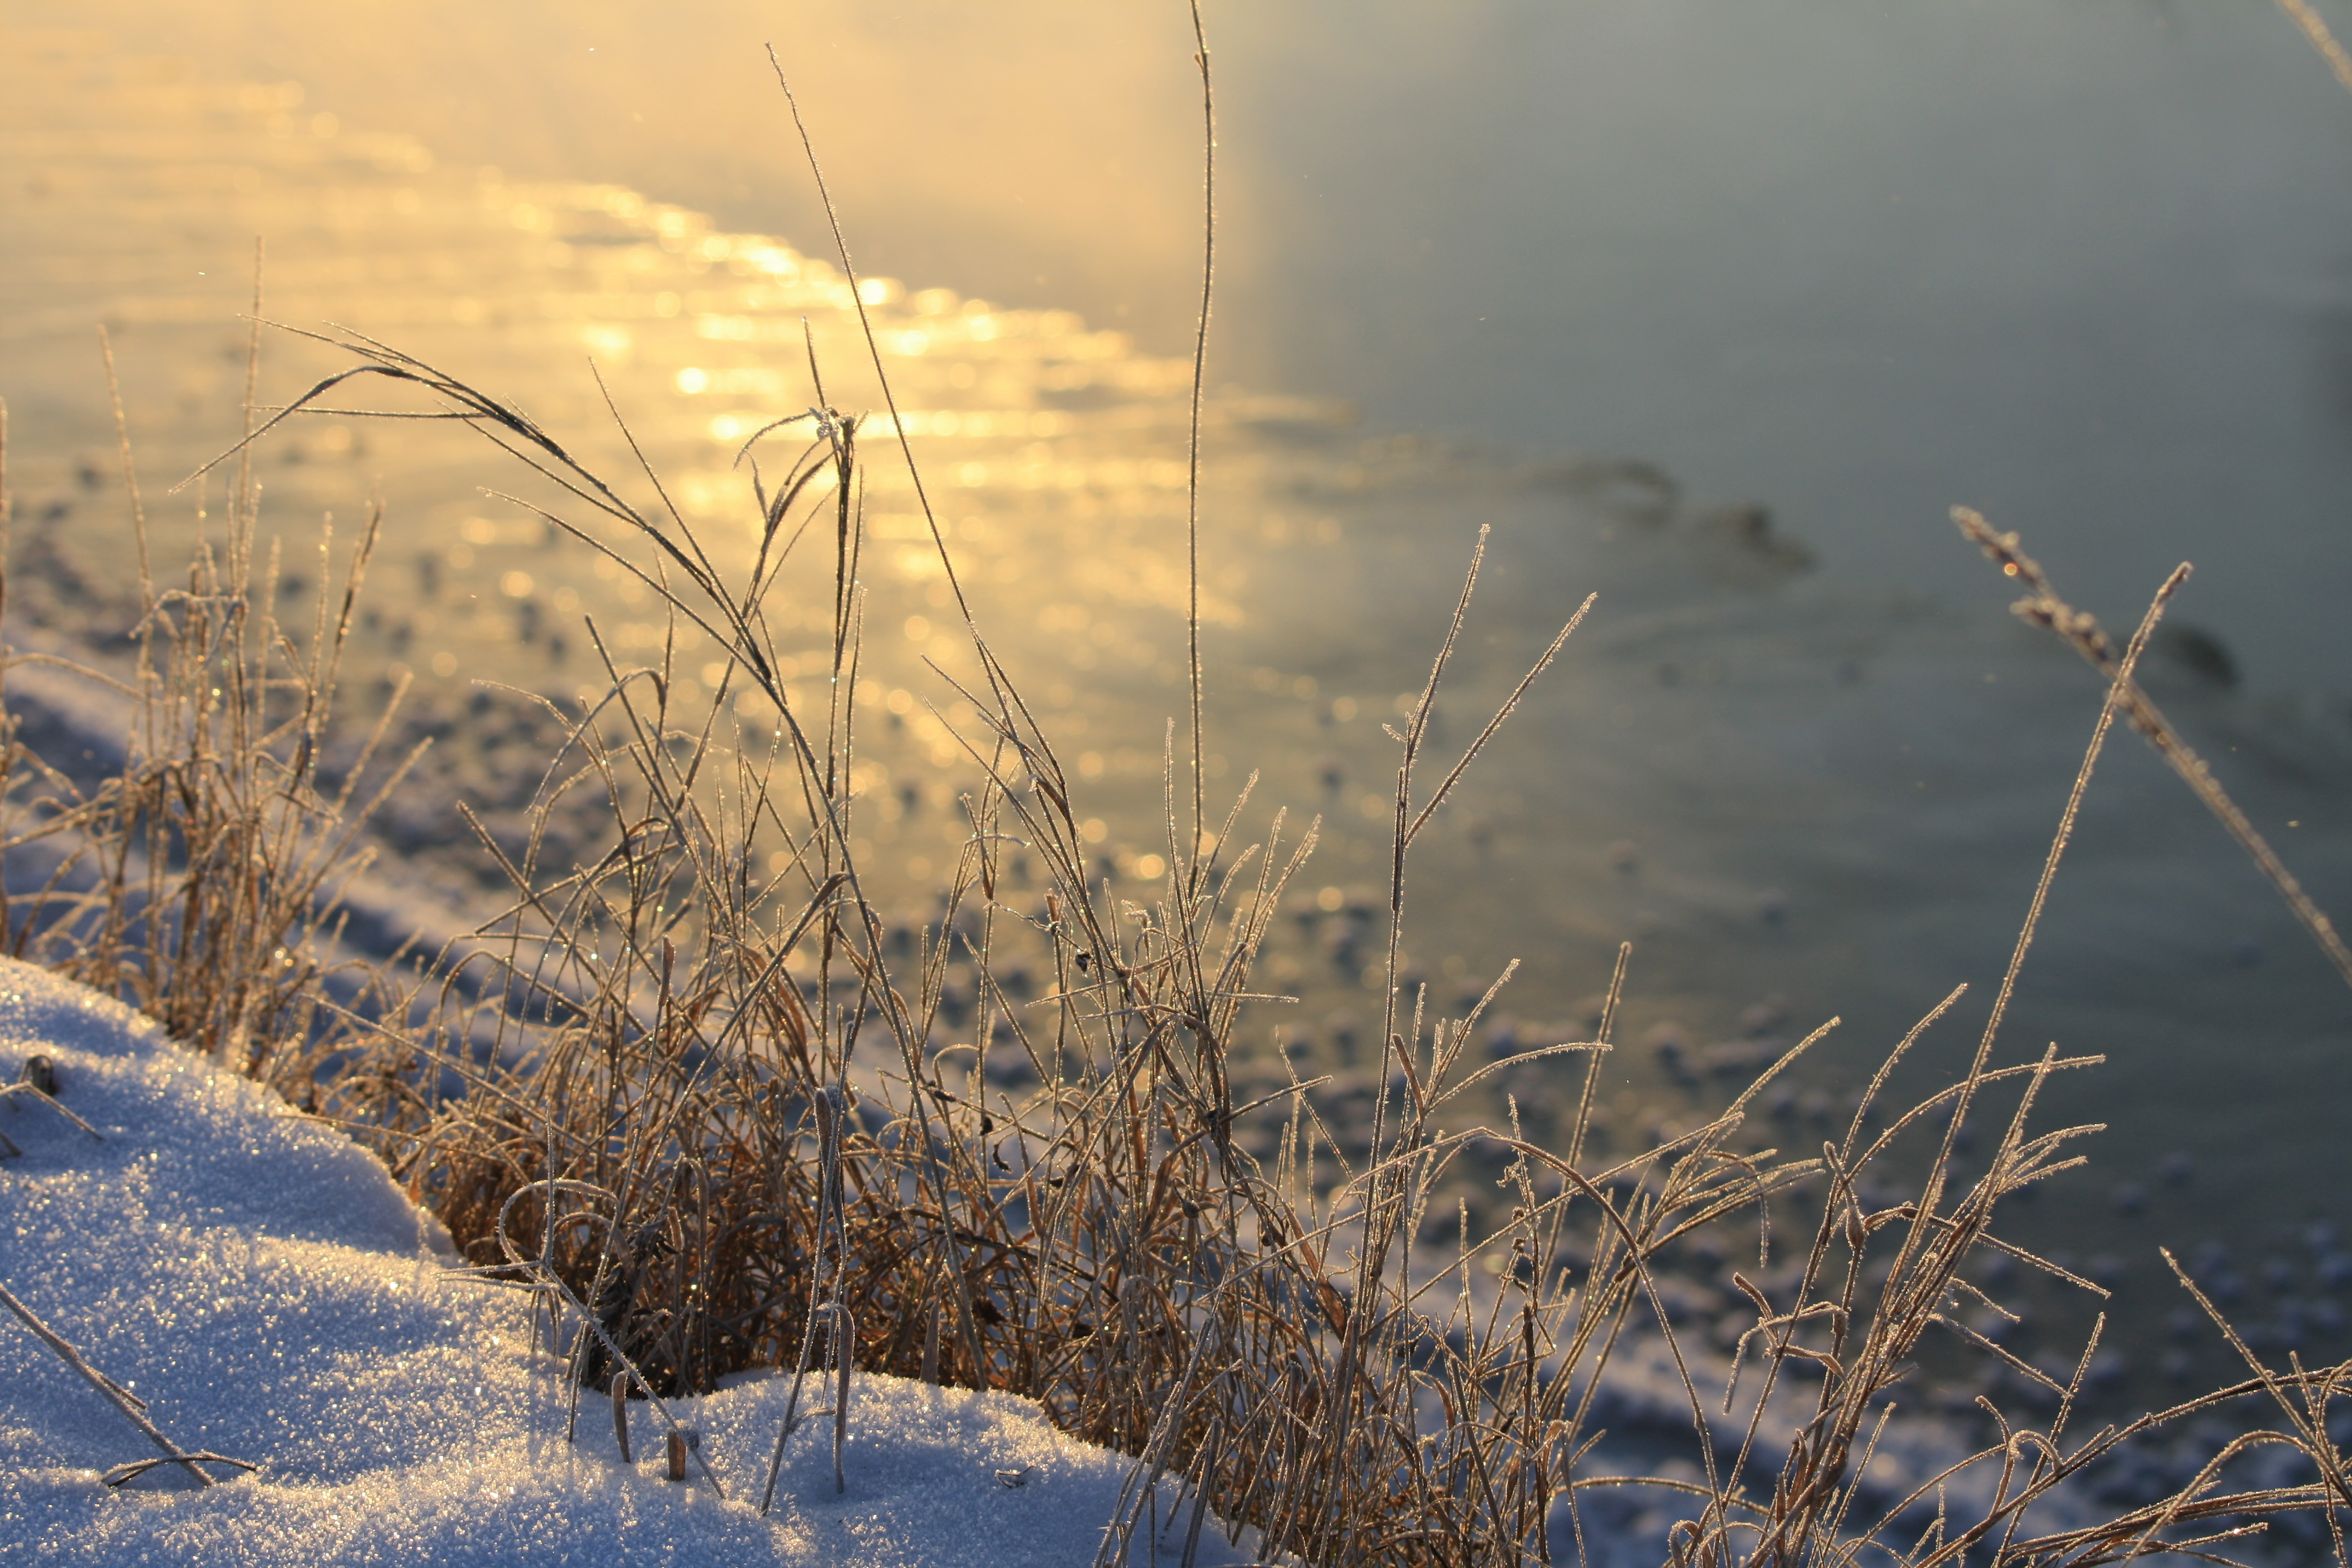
[0,312,407,1105]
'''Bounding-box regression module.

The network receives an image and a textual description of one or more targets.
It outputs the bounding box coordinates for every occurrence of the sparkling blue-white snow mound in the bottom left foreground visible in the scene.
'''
[0,959,1249,1568]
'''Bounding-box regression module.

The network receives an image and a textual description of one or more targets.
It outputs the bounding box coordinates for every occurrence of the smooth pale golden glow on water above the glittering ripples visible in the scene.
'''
[10,0,1240,348]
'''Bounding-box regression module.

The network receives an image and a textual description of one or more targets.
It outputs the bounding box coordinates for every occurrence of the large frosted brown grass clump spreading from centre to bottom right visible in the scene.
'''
[9,310,2352,1566]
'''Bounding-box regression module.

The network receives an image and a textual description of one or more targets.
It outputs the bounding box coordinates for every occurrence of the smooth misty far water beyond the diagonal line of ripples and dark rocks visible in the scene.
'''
[32,0,2352,679]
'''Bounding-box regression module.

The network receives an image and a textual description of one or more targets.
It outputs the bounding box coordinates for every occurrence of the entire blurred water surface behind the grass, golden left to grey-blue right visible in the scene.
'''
[0,0,2352,1420]
